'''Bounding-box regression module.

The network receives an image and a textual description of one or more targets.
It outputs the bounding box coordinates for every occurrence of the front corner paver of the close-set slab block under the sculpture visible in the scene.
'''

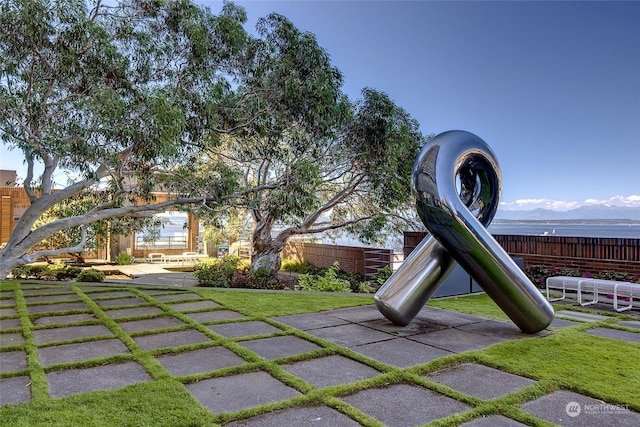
[352,338,454,368]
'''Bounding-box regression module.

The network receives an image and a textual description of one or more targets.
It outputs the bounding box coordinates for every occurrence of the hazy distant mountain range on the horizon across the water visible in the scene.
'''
[495,205,640,222]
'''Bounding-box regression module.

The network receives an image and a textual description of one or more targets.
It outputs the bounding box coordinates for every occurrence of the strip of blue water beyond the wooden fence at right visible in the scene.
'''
[489,222,640,239]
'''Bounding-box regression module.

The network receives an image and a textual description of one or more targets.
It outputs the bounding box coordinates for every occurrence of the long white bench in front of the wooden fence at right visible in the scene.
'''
[546,276,640,312]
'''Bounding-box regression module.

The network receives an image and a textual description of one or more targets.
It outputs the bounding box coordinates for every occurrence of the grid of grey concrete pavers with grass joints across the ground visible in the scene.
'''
[0,284,640,427]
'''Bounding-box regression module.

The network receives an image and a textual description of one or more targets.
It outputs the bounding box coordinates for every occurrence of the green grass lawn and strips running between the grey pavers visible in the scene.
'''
[0,281,640,426]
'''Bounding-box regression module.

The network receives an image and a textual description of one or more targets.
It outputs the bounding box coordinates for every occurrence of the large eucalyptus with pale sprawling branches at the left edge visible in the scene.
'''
[0,0,248,278]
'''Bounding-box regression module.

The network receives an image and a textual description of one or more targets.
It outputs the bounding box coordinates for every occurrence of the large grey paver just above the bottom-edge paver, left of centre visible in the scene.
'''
[185,371,301,414]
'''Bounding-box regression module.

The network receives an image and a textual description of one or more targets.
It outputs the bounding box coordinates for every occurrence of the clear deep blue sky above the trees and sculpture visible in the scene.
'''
[0,0,640,210]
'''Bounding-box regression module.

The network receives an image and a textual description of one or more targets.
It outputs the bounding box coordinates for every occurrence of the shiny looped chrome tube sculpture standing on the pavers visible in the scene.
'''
[375,131,553,333]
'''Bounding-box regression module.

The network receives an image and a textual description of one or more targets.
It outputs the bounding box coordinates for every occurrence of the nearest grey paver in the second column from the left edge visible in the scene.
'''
[46,362,152,399]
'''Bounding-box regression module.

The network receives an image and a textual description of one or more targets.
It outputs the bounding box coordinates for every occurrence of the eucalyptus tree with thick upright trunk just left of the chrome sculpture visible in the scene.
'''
[188,14,424,271]
